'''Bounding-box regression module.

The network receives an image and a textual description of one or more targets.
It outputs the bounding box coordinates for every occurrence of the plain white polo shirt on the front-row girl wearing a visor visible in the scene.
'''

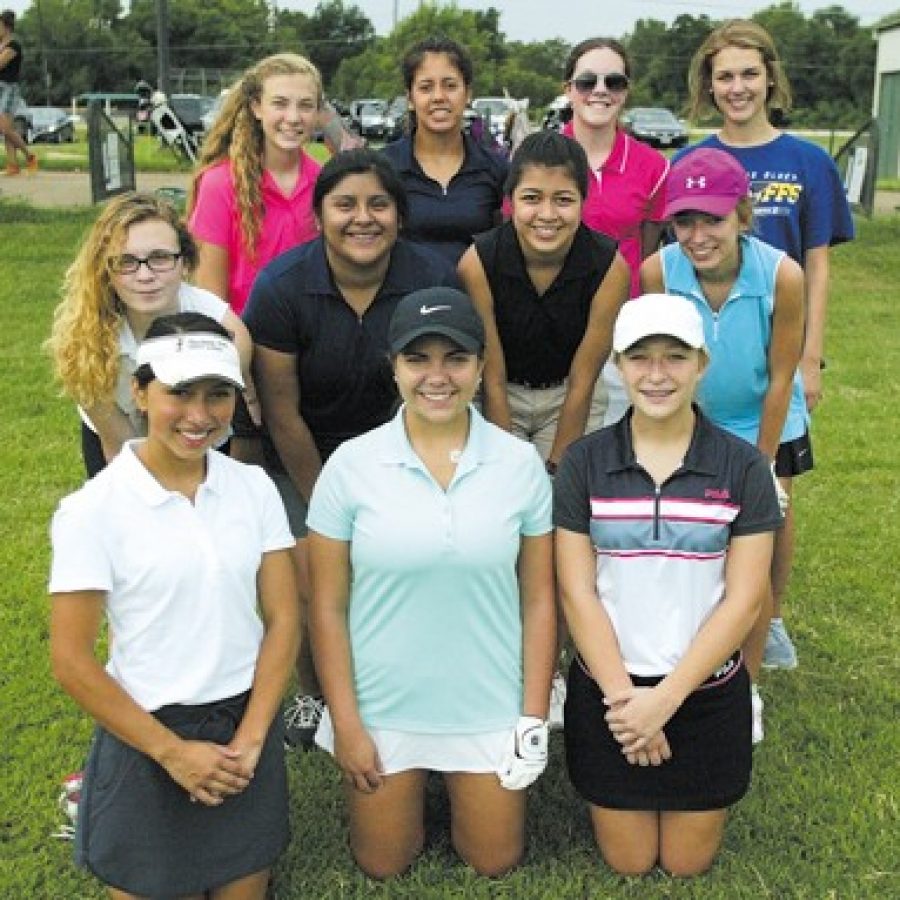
[50,441,294,710]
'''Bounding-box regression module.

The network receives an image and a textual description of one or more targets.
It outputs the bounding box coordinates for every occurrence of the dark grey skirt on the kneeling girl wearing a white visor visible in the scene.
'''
[75,693,289,897]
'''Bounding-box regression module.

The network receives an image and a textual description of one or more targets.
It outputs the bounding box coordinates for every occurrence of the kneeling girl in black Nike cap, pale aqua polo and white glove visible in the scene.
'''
[309,287,555,878]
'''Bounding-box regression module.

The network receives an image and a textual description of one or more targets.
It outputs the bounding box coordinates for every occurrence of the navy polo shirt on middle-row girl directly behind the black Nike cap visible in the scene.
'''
[244,238,459,460]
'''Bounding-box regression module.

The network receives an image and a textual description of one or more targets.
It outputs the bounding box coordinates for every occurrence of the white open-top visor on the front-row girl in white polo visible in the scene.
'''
[137,332,244,389]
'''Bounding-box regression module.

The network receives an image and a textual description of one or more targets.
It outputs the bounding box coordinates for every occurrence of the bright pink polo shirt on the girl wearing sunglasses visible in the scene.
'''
[562,122,669,297]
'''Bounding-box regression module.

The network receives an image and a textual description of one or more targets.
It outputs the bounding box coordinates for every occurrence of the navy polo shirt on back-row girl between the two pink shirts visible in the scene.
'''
[382,134,509,266]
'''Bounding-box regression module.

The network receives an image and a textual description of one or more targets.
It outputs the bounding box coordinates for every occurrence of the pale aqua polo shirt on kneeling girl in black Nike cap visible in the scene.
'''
[307,407,552,734]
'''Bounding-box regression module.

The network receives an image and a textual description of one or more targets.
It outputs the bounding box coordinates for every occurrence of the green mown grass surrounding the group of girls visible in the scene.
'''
[0,203,900,900]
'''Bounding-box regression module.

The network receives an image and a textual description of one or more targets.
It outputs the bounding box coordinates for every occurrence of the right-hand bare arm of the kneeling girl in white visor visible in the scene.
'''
[229,550,300,776]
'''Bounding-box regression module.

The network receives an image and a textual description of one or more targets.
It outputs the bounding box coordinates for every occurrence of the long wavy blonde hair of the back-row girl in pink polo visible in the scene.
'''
[188,53,322,259]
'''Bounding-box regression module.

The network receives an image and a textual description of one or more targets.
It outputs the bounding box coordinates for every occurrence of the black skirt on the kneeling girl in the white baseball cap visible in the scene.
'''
[565,655,752,812]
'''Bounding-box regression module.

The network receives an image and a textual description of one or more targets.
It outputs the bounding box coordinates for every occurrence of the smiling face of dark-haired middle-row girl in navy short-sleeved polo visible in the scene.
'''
[319,172,400,271]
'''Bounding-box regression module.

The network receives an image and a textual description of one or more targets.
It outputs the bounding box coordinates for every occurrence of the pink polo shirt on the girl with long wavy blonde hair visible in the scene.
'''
[188,153,322,315]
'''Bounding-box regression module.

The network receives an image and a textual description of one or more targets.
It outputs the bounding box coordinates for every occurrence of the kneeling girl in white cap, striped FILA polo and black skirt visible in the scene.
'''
[554,295,781,875]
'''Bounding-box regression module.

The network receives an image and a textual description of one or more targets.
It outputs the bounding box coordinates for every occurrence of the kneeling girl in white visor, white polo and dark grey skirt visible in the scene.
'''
[50,314,299,898]
